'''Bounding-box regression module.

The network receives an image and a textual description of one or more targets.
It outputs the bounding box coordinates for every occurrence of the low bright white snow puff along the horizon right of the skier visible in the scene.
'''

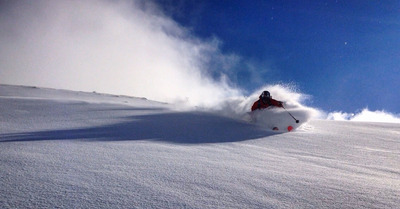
[327,108,400,123]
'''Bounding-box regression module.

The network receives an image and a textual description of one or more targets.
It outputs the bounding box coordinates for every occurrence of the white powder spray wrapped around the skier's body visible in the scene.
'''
[209,84,322,130]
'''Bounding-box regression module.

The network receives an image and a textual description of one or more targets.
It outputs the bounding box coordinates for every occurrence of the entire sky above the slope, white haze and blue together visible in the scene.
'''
[0,0,400,114]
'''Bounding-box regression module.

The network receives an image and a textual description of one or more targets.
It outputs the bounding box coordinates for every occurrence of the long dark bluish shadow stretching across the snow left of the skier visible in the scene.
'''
[0,112,276,144]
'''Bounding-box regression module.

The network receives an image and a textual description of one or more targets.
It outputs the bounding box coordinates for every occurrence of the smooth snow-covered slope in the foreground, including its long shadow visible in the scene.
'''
[0,85,400,208]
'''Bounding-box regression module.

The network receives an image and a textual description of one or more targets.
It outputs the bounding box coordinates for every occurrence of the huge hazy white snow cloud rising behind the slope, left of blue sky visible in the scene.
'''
[0,0,240,105]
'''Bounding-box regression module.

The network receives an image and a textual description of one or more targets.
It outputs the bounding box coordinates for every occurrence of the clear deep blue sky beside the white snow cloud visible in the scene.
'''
[156,0,400,113]
